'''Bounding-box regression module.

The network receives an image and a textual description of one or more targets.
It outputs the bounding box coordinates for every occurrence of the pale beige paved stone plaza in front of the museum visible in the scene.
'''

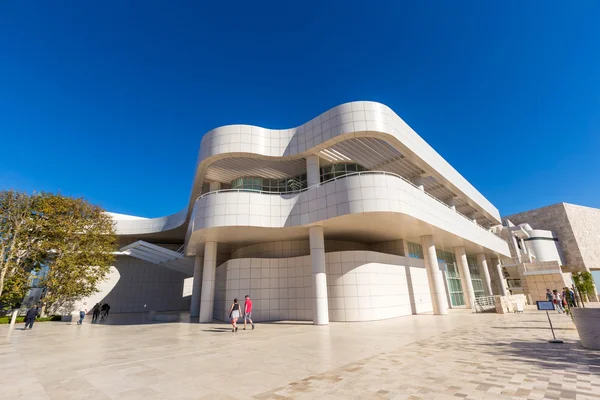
[0,309,600,400]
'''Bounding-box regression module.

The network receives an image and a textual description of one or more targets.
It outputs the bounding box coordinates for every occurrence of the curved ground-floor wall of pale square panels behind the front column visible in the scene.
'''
[214,250,432,321]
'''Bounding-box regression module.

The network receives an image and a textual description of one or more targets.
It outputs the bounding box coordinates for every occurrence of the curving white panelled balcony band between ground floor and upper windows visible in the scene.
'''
[188,172,507,254]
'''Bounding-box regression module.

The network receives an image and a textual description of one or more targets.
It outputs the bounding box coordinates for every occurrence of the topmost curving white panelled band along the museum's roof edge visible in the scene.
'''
[198,101,507,225]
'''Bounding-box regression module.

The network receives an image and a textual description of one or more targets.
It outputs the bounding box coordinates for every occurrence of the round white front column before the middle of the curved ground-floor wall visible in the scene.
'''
[308,226,329,325]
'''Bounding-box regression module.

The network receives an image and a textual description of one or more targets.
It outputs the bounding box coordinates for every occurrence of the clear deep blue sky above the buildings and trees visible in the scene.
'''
[0,1,600,217]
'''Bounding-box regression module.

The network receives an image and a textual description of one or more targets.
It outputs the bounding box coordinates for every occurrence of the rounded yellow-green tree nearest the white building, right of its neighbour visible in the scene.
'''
[37,193,117,312]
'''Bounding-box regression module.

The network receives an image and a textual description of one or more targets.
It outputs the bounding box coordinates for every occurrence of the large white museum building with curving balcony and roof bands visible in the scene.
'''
[87,102,510,325]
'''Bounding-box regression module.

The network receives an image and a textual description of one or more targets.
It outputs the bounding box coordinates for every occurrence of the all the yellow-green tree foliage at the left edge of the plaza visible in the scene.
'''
[0,191,117,310]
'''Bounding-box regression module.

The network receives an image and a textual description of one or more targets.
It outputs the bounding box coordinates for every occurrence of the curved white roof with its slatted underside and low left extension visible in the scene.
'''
[114,101,500,241]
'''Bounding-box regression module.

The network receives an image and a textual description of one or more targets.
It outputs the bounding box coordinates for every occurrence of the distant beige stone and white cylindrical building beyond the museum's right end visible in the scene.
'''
[502,203,600,301]
